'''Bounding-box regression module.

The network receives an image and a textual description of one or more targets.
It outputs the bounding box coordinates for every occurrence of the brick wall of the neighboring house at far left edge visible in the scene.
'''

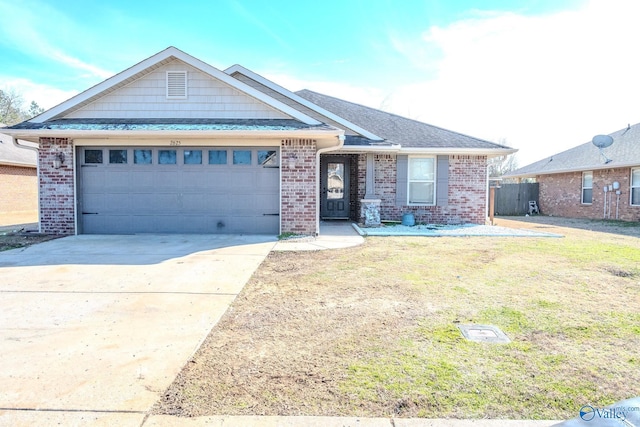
[0,165,38,213]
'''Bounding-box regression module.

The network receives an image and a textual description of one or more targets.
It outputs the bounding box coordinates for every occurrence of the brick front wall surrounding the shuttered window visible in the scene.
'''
[358,154,487,224]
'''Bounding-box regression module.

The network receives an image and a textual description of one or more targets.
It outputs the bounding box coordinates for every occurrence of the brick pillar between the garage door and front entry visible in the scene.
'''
[280,139,318,235]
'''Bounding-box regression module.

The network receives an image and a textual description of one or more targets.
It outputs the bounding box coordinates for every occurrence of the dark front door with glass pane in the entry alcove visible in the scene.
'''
[320,156,350,219]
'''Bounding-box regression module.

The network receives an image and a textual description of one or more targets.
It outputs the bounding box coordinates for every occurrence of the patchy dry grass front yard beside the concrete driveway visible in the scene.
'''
[155,220,640,419]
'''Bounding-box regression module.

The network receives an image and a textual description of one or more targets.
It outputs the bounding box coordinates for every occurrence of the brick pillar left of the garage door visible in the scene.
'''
[38,138,75,235]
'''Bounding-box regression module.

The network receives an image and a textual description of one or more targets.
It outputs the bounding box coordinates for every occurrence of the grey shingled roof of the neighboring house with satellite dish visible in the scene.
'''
[505,124,640,178]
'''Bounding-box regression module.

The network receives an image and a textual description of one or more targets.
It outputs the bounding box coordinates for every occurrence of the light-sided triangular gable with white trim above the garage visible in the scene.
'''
[30,47,320,125]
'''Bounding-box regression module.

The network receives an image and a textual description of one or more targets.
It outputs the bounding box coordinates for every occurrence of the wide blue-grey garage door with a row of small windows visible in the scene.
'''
[78,147,280,234]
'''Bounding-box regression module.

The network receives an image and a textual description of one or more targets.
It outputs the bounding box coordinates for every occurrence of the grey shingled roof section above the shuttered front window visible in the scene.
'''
[296,89,510,150]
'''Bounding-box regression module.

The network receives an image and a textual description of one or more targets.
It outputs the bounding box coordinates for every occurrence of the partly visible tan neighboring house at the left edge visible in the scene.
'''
[0,129,38,215]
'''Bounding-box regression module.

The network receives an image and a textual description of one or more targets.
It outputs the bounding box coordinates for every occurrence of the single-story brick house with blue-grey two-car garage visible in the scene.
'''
[3,47,515,234]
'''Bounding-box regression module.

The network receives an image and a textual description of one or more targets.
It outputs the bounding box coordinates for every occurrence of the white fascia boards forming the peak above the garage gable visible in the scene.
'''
[29,46,321,125]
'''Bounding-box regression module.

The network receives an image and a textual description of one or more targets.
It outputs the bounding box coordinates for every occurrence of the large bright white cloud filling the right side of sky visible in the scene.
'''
[372,0,640,165]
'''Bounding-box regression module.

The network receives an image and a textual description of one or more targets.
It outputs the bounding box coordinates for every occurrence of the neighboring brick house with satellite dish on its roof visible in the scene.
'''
[505,125,640,221]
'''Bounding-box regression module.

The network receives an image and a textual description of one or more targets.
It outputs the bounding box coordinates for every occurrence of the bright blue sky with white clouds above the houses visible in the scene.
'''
[0,0,640,165]
